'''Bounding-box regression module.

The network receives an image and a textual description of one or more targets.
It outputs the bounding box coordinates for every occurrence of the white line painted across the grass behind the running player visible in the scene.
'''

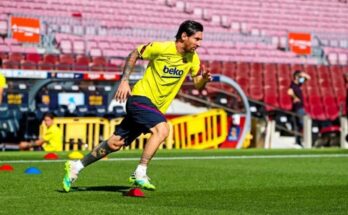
[0,154,348,163]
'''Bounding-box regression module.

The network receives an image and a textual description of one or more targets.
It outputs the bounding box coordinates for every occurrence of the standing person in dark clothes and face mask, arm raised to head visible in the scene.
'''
[288,70,311,146]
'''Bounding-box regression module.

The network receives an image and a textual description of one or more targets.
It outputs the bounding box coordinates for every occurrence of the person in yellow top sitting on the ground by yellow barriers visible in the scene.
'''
[19,113,63,152]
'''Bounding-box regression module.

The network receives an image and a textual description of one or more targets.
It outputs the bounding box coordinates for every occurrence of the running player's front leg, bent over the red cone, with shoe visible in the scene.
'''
[130,122,169,190]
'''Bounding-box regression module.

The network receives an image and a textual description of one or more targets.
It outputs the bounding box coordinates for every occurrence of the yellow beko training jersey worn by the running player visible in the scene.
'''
[132,41,200,113]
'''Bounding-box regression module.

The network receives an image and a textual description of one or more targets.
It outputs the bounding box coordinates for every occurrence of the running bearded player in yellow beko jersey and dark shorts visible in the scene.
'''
[63,20,211,192]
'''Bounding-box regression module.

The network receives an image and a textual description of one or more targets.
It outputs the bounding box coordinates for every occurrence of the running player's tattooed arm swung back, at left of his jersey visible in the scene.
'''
[115,50,139,102]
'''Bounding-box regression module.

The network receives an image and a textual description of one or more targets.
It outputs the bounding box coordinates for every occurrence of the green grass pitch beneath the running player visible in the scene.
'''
[0,149,348,215]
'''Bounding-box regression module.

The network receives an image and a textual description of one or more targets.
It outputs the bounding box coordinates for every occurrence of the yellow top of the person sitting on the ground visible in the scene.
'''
[42,125,63,152]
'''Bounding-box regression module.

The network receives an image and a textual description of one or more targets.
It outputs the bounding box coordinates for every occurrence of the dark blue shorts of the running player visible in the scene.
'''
[114,96,167,146]
